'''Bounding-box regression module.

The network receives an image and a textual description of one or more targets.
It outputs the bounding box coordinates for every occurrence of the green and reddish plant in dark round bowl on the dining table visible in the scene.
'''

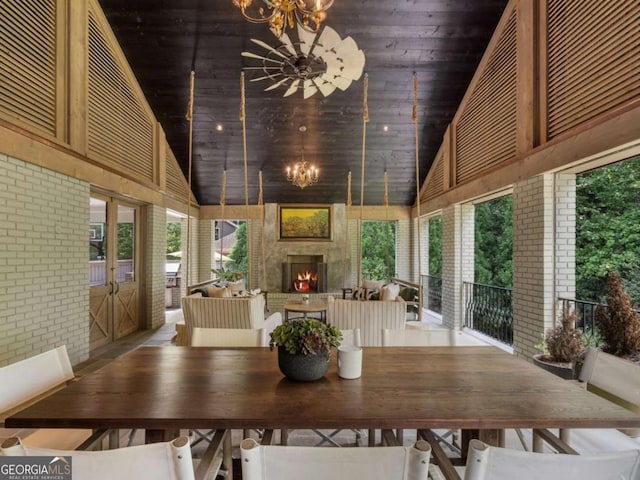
[269,318,342,382]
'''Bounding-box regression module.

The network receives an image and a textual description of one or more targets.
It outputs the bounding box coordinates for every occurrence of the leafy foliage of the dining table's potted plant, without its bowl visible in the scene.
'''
[269,318,342,358]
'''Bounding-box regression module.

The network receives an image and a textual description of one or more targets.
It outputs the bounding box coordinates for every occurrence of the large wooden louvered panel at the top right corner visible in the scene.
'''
[547,0,640,139]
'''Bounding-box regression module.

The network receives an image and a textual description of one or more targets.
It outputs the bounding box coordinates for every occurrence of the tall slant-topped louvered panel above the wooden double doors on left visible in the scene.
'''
[88,12,153,181]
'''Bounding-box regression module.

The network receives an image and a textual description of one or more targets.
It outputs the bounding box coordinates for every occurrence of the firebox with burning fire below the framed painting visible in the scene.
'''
[282,255,327,293]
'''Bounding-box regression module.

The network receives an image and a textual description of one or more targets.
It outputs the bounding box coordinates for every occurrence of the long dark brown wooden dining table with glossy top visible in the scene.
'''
[5,346,640,441]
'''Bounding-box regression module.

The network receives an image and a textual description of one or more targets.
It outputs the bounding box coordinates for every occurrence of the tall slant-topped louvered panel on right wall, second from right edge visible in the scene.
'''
[455,10,517,184]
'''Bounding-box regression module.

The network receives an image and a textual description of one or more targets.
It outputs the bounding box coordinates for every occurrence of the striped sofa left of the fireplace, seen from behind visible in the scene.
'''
[176,293,282,345]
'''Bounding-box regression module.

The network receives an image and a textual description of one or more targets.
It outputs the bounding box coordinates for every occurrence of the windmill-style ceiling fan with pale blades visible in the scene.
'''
[242,26,365,99]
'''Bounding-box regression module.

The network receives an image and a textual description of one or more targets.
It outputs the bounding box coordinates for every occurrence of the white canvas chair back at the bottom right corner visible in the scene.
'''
[464,440,640,480]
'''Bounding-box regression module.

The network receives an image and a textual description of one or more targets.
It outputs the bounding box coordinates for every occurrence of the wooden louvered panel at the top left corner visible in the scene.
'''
[0,0,56,135]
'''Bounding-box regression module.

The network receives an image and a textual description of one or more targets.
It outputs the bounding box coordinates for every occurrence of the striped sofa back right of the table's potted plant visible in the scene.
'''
[327,297,407,347]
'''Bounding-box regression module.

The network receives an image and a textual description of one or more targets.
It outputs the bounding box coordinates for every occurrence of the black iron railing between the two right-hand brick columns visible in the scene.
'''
[464,282,513,345]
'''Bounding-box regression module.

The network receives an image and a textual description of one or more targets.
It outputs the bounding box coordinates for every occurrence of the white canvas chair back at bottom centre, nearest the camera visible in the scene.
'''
[240,438,431,480]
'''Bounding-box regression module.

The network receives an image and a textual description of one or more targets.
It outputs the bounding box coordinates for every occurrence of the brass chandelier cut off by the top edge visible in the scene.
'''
[232,0,334,37]
